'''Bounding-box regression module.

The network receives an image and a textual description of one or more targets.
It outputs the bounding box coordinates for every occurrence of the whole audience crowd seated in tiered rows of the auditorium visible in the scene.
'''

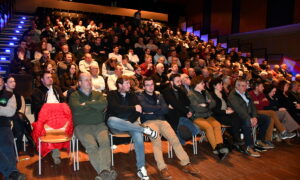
[0,10,300,179]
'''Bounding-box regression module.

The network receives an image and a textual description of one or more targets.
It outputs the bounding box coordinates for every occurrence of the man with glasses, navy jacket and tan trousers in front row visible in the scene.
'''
[138,78,199,179]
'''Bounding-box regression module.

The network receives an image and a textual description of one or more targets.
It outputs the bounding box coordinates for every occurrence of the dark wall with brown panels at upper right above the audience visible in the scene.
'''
[185,0,300,36]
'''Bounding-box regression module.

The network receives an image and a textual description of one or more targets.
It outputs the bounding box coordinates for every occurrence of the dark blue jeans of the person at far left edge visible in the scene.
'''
[0,127,18,179]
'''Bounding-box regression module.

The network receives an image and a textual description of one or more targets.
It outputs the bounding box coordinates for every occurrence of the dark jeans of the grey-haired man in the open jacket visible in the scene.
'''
[241,114,271,147]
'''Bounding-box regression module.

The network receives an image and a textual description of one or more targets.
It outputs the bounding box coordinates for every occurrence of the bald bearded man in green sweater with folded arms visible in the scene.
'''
[69,73,117,180]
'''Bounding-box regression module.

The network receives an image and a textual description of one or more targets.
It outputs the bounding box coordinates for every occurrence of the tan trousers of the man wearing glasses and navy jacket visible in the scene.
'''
[143,120,190,171]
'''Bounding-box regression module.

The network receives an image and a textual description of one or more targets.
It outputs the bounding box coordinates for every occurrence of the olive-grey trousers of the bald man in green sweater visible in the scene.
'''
[75,123,111,174]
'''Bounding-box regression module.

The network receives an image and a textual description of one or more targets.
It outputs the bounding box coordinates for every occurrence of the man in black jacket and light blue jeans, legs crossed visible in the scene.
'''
[107,76,157,180]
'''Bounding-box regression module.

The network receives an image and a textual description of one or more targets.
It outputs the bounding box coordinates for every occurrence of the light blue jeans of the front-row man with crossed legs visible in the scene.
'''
[107,117,145,169]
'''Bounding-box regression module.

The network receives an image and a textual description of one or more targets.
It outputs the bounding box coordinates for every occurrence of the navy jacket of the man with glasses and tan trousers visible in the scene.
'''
[138,92,168,123]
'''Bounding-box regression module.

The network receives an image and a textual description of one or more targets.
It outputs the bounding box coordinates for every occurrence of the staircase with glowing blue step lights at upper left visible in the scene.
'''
[0,13,33,76]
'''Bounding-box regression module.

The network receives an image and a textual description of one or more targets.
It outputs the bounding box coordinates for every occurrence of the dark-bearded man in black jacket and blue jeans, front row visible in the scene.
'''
[162,74,200,144]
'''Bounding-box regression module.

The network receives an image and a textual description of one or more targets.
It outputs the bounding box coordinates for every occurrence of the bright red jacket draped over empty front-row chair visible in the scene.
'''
[32,103,73,157]
